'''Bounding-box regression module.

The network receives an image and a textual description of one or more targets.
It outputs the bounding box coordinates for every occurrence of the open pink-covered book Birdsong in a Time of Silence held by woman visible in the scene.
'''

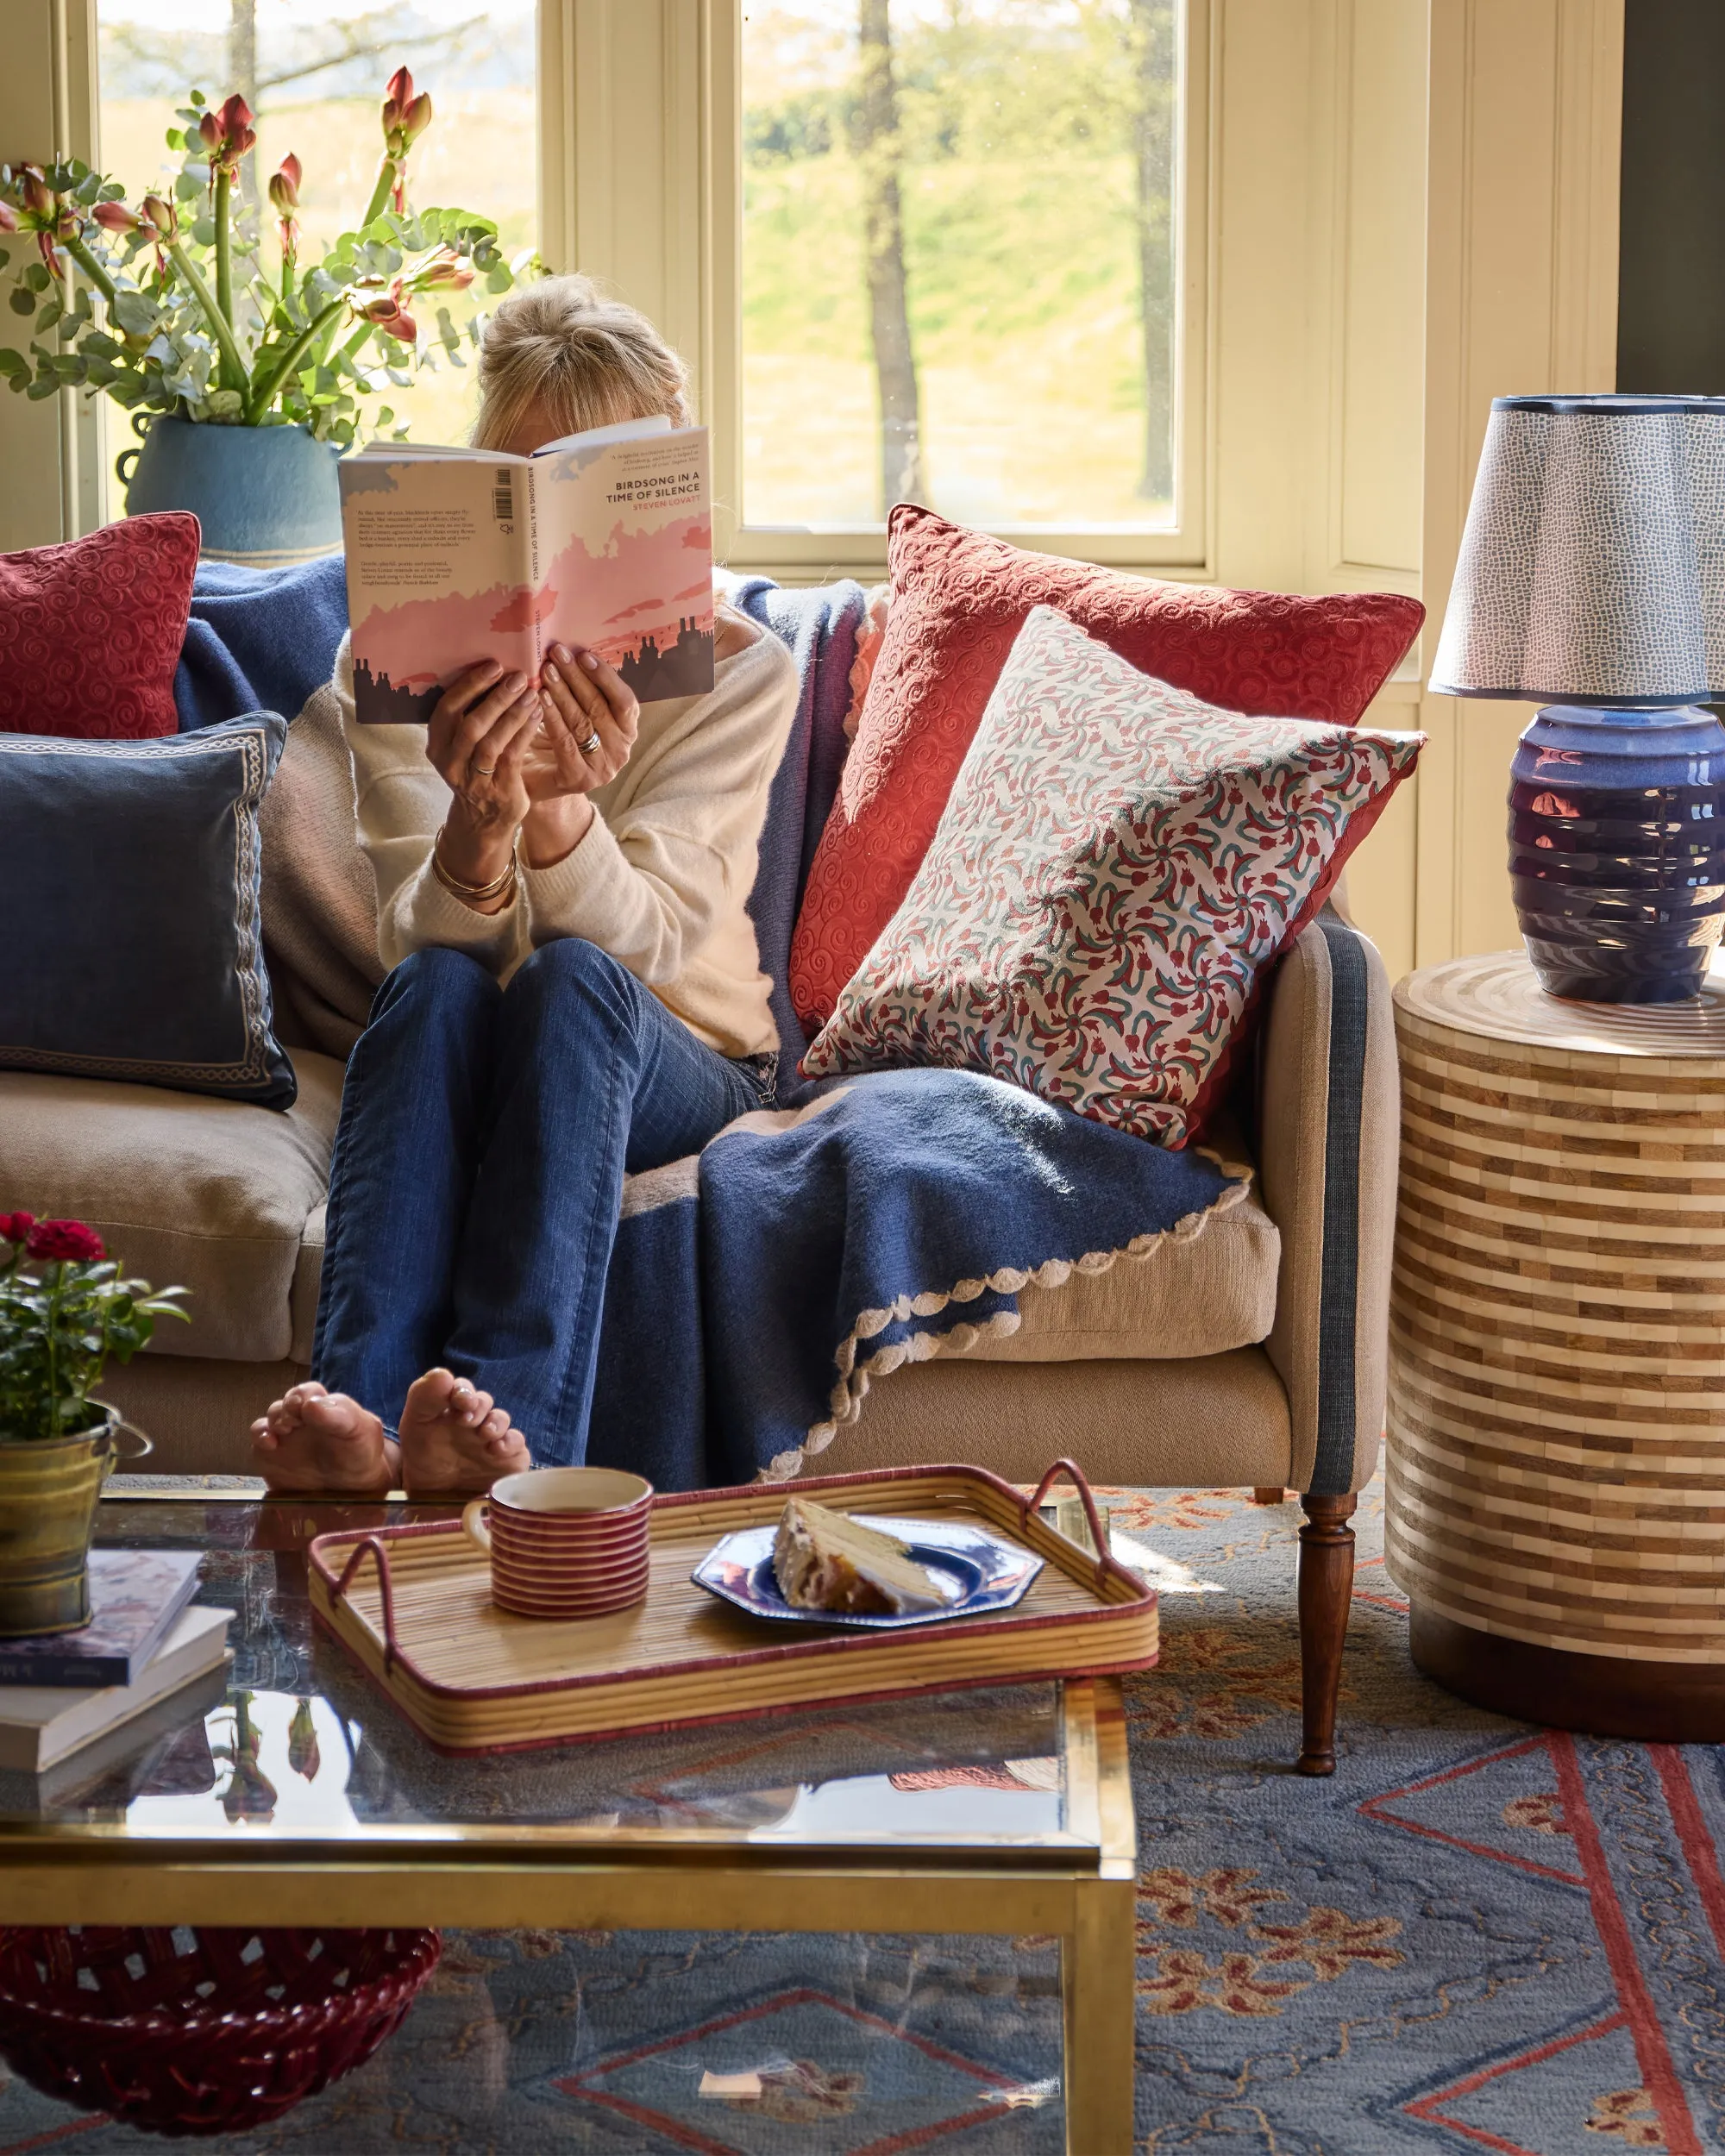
[339,418,714,724]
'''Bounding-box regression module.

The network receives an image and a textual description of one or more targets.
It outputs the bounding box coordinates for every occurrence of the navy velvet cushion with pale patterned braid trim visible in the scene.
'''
[0,711,296,1108]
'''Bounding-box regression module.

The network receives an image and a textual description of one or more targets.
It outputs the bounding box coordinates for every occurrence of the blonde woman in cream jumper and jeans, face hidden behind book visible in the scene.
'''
[253,279,796,1492]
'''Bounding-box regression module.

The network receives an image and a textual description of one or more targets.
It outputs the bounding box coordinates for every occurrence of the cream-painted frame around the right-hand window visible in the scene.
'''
[706,0,1214,585]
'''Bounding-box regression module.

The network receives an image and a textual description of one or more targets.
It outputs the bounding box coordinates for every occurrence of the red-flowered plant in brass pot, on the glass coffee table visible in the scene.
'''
[0,1214,185,1639]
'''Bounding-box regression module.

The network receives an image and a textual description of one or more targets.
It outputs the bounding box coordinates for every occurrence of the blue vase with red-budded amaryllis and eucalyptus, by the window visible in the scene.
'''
[0,67,513,567]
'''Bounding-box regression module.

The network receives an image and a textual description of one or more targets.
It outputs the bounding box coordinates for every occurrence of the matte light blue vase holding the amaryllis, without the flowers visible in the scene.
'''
[115,417,341,569]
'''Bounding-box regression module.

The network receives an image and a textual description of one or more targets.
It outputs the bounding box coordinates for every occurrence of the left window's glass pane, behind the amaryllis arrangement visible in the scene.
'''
[99,0,537,516]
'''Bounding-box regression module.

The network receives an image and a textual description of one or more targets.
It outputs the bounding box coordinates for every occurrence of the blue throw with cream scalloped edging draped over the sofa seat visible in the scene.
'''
[586,1072,1246,1490]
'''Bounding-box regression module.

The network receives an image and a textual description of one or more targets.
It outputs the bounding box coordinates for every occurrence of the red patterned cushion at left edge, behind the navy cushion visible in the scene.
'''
[0,509,198,742]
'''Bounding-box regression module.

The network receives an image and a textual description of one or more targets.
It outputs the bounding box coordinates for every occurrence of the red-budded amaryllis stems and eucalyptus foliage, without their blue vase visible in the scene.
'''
[0,67,524,448]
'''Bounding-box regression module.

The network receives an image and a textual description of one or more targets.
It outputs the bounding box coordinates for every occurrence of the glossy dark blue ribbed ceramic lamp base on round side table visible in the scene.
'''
[1509,703,1725,1003]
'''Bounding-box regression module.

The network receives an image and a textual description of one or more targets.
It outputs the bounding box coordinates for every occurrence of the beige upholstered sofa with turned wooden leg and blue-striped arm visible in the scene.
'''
[0,617,1400,1775]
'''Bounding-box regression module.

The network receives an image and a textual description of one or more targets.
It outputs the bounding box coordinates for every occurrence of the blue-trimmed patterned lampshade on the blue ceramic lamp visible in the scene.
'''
[1432,397,1725,705]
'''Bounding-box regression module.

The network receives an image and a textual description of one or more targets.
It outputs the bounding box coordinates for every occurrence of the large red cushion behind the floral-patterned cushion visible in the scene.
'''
[792,503,1426,1033]
